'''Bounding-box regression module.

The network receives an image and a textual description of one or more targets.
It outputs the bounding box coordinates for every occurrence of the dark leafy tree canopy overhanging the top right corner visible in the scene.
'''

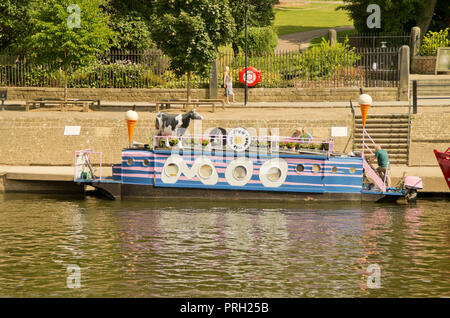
[338,0,442,35]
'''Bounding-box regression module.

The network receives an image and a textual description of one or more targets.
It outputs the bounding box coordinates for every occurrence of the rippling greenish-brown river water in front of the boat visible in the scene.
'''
[0,194,450,298]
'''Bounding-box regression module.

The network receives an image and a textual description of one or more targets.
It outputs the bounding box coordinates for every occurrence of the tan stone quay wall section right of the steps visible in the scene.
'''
[409,110,450,166]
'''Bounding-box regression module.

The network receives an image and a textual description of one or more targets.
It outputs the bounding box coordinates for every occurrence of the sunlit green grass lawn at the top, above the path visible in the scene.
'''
[275,3,353,35]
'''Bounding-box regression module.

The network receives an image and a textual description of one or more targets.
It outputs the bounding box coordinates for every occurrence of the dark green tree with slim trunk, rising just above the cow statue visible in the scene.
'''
[152,0,234,103]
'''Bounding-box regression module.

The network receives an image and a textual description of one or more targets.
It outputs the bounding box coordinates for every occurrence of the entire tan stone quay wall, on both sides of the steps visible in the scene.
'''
[0,108,450,166]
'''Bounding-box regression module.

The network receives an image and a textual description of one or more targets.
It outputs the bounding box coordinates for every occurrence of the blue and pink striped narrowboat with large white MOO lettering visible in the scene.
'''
[74,127,422,202]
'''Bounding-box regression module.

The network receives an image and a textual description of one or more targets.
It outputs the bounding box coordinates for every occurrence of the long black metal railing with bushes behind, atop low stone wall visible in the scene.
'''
[0,48,399,89]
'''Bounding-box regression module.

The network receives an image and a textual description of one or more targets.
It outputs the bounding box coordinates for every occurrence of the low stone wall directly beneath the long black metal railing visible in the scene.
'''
[0,87,398,103]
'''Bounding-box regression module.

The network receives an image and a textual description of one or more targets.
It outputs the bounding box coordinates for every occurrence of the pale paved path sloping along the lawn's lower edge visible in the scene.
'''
[277,26,355,51]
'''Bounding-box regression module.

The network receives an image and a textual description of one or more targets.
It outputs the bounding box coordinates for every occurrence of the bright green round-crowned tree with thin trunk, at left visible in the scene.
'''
[25,0,113,101]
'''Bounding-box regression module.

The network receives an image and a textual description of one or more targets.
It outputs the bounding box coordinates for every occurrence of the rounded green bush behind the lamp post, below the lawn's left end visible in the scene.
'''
[236,26,278,55]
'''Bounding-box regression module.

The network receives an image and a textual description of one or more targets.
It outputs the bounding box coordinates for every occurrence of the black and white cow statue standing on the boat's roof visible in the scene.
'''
[155,109,203,147]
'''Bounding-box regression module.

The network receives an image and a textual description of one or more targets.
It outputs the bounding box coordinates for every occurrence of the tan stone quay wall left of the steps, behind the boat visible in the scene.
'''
[0,111,352,166]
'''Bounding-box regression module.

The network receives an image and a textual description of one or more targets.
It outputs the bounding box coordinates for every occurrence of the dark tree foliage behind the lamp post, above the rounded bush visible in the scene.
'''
[229,0,278,55]
